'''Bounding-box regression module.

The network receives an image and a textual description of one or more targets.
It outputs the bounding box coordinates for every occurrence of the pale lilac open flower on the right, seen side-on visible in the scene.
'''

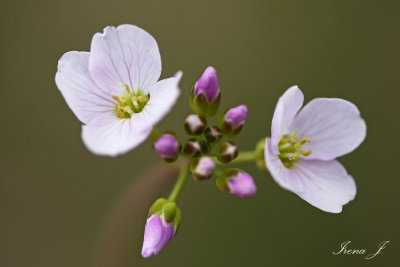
[264,86,366,213]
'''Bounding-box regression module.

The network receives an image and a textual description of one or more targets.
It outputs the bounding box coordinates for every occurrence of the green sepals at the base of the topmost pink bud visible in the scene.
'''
[189,88,221,117]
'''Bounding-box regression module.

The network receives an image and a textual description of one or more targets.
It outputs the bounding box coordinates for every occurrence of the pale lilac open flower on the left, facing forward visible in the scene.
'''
[56,25,182,156]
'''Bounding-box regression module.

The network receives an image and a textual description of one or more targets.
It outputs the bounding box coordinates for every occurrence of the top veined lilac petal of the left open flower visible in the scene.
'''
[89,25,161,95]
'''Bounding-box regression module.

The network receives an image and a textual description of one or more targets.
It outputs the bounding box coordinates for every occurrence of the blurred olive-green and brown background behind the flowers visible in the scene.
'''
[0,0,400,267]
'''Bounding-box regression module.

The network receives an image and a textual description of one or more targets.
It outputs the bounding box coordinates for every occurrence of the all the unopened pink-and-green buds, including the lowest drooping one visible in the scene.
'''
[148,67,256,257]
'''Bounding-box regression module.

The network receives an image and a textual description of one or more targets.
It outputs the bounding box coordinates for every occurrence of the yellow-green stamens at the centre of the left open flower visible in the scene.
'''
[112,84,150,119]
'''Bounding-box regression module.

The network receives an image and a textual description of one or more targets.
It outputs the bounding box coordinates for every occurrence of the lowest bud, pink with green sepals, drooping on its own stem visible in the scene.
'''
[142,198,182,258]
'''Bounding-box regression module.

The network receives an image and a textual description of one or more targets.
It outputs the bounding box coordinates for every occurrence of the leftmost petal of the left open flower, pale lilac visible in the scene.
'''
[55,51,114,123]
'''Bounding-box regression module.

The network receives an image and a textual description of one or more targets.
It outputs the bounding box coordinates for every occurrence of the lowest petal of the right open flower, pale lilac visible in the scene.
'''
[265,139,357,213]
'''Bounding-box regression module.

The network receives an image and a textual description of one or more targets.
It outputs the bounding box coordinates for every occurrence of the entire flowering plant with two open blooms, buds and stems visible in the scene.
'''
[55,25,366,257]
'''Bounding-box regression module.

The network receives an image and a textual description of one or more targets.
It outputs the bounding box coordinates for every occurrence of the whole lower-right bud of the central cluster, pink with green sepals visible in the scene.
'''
[216,169,257,198]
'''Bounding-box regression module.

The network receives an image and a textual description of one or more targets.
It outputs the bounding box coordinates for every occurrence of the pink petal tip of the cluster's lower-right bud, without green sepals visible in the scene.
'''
[227,172,257,198]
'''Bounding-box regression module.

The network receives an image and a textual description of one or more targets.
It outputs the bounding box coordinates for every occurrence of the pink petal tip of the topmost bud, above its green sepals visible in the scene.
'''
[194,66,219,102]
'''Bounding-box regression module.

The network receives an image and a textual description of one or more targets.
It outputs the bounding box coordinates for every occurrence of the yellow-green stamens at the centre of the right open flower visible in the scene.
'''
[278,134,312,169]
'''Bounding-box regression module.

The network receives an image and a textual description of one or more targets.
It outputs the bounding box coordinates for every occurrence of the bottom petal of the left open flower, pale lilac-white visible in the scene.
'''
[82,112,152,157]
